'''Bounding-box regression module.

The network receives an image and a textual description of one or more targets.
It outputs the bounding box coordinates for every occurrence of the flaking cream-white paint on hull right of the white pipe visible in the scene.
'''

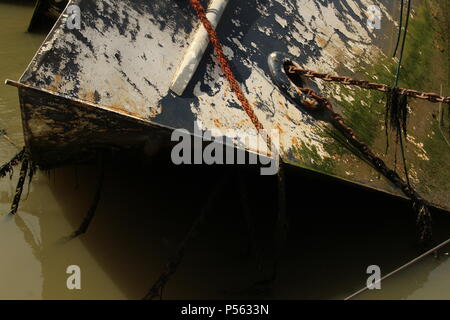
[186,1,394,162]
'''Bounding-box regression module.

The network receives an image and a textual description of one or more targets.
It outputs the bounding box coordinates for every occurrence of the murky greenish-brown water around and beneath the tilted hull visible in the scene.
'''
[0,1,450,299]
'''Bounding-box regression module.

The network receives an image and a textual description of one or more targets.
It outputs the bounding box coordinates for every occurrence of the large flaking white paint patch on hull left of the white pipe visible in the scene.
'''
[24,0,193,119]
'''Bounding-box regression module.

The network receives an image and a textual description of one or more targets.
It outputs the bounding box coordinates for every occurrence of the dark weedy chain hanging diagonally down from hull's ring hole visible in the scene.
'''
[297,87,431,243]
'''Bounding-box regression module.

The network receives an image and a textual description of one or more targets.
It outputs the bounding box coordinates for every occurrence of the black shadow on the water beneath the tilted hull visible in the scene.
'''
[37,148,450,299]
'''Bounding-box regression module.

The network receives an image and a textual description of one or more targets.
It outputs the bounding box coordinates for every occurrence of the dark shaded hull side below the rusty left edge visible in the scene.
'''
[13,84,170,169]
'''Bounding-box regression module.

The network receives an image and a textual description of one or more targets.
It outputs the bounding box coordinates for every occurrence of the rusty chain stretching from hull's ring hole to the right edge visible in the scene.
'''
[288,66,450,103]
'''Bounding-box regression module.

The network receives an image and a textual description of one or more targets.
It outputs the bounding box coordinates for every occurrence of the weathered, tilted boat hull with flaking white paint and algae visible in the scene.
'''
[4,0,450,214]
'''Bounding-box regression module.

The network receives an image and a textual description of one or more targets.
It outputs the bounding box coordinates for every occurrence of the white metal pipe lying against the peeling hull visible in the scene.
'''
[170,0,229,96]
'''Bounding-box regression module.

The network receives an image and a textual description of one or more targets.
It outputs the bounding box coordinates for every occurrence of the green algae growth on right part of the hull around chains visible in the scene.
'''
[292,0,450,210]
